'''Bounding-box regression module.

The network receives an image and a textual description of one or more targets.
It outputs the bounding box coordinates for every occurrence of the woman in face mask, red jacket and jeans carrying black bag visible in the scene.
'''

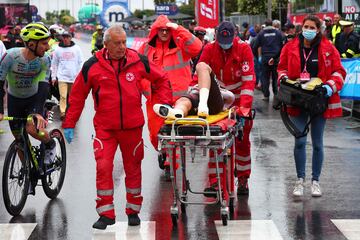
[278,15,346,197]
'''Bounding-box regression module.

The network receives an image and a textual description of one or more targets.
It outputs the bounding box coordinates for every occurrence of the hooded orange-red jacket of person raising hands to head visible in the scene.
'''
[139,15,202,101]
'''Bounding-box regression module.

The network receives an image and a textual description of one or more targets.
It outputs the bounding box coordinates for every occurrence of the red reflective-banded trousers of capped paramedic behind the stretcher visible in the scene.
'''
[208,120,253,185]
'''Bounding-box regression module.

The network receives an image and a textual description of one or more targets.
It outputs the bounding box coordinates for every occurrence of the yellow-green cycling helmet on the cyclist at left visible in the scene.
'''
[20,23,50,42]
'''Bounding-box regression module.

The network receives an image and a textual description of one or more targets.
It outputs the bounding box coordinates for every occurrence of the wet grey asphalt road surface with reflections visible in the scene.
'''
[0,36,360,240]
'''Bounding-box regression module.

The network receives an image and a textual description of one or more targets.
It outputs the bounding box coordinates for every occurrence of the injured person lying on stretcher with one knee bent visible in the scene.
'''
[153,64,235,119]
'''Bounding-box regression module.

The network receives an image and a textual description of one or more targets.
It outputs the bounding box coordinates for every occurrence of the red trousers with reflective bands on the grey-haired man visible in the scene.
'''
[93,127,144,219]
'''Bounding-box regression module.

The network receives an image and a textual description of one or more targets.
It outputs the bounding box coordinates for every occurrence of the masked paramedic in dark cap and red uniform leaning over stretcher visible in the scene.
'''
[200,21,255,195]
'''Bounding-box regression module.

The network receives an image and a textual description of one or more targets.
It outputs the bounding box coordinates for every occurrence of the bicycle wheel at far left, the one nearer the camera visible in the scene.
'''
[2,141,30,216]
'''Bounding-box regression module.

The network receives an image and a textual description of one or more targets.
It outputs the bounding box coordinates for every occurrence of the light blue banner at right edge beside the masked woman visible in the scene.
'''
[340,58,360,100]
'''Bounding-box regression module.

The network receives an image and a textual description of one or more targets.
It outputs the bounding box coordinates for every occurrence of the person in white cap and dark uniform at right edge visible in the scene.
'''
[335,20,360,58]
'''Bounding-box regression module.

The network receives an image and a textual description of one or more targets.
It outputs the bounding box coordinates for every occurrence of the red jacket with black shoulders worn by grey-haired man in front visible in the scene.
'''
[62,48,172,130]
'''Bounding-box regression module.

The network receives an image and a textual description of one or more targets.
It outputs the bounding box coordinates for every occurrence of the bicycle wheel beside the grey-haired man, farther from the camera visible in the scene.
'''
[41,129,66,199]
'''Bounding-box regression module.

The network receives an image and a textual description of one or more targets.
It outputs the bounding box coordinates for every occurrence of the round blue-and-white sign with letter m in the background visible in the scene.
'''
[100,0,130,27]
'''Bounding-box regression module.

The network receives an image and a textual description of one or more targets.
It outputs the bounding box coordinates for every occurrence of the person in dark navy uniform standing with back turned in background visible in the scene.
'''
[256,19,283,101]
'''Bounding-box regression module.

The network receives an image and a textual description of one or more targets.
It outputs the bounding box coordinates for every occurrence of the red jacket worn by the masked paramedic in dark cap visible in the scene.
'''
[199,39,255,108]
